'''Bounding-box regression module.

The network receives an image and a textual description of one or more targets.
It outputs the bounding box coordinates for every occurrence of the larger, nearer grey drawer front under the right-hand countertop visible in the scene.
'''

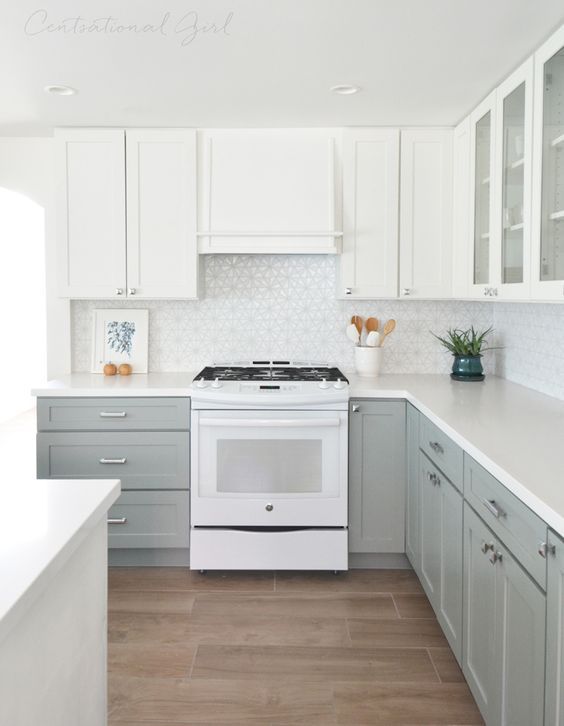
[464,454,547,588]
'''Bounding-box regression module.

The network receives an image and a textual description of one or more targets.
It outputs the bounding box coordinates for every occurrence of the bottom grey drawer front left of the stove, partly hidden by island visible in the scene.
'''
[108,491,190,548]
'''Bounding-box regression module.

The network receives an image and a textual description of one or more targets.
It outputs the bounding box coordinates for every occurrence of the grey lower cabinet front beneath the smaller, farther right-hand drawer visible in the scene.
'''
[419,451,463,663]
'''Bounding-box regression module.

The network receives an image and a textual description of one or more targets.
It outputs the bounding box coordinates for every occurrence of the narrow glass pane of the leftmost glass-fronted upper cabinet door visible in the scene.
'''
[474,111,492,285]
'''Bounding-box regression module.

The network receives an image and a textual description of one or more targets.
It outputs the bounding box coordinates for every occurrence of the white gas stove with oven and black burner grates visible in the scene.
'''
[190,361,349,570]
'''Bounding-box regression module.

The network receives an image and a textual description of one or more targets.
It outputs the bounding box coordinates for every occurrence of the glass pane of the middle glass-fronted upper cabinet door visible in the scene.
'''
[501,83,525,284]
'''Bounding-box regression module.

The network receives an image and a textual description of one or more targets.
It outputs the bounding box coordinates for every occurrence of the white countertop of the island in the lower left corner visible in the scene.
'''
[0,479,121,643]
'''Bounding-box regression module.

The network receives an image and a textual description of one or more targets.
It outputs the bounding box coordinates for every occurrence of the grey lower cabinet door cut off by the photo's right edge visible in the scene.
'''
[544,532,564,726]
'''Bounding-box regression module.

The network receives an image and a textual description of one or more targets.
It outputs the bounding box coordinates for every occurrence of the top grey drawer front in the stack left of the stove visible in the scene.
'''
[37,397,190,431]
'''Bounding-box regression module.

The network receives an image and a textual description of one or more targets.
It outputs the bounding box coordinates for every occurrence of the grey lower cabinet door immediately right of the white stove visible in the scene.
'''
[349,400,406,553]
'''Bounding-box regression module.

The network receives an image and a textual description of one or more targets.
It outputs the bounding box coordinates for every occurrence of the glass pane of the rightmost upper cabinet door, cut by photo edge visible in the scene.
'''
[540,49,564,280]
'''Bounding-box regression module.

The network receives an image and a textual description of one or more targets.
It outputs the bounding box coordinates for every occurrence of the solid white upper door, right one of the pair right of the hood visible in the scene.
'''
[400,129,452,298]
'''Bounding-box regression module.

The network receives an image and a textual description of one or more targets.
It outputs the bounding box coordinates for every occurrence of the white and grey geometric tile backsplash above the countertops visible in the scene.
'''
[71,255,564,398]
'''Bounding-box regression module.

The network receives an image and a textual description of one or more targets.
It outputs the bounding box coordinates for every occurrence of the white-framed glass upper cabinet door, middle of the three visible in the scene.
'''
[494,58,533,299]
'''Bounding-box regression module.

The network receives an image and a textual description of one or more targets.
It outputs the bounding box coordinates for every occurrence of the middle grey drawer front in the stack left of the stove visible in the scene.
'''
[37,431,190,489]
